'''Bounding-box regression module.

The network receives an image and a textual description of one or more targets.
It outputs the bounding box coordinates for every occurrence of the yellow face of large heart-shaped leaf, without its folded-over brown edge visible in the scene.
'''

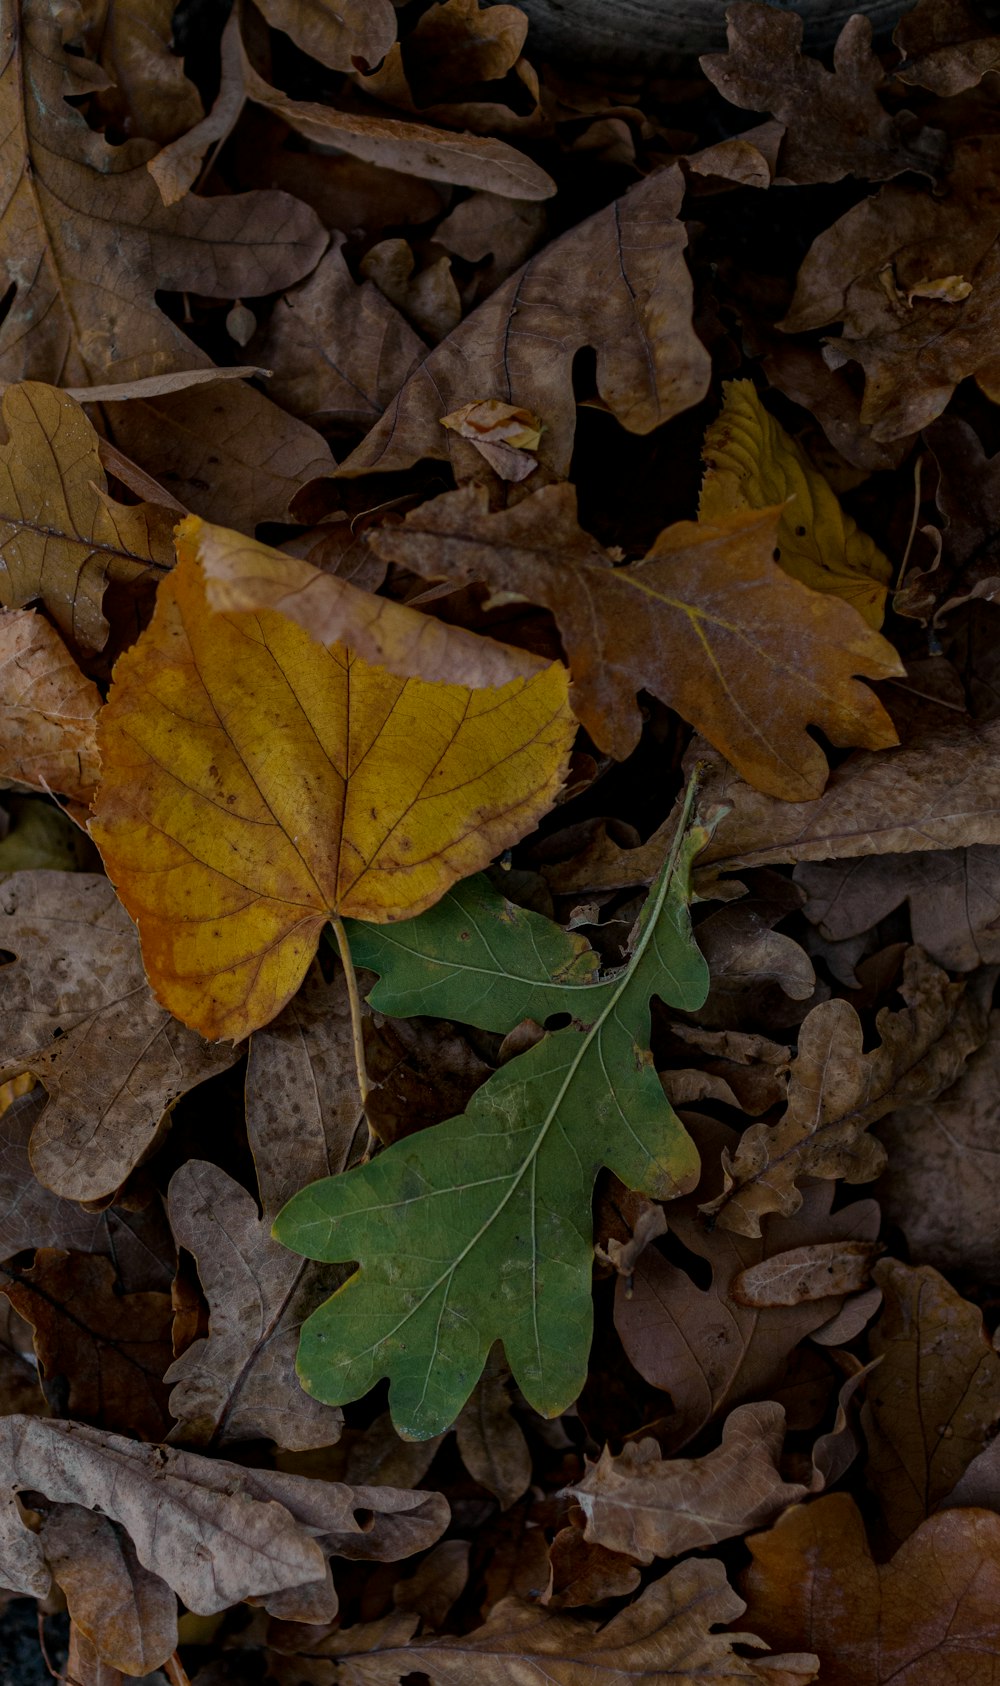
[91,519,573,1039]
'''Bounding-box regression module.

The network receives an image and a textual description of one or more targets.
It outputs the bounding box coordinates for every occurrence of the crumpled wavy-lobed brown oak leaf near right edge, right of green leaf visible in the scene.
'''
[700,948,995,1236]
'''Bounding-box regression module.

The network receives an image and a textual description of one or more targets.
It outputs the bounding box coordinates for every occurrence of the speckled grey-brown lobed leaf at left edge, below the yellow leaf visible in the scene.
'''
[0,872,234,1200]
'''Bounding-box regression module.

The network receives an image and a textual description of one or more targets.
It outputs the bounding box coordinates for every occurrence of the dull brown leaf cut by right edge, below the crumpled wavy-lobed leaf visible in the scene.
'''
[876,1012,1000,1281]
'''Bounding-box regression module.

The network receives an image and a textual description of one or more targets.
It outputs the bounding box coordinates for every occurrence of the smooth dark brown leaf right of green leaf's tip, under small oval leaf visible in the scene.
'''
[614,1113,879,1450]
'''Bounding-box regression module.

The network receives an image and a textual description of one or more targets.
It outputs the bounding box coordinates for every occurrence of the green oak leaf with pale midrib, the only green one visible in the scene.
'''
[273,802,708,1440]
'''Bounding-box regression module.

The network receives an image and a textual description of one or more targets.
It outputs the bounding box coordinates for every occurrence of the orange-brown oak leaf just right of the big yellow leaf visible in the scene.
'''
[369,485,902,801]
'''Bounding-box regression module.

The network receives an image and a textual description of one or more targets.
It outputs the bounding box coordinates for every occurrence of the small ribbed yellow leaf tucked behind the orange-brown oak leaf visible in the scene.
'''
[698,381,892,631]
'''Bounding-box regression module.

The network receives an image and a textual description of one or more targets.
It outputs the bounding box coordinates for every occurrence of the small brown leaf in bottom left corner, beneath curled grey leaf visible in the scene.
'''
[40,1504,177,1676]
